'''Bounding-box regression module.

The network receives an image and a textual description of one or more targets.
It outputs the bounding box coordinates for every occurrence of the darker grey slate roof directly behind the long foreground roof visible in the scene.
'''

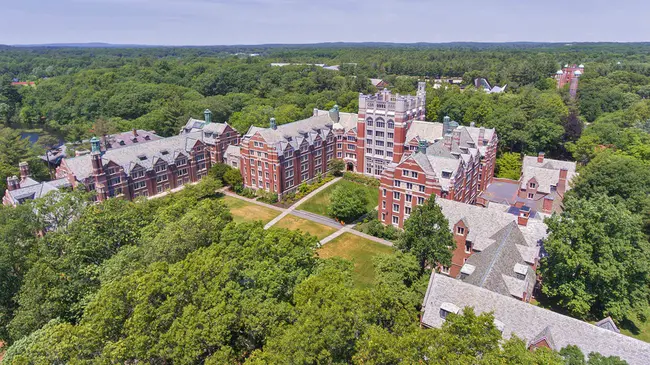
[460,221,539,299]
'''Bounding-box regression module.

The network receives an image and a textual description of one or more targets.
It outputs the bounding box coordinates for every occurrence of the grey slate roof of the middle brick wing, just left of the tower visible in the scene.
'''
[242,110,359,154]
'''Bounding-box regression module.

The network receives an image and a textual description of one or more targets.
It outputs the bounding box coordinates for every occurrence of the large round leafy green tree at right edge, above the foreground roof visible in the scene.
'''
[540,195,650,321]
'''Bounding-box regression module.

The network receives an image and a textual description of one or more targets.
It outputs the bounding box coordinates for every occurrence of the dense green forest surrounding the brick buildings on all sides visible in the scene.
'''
[0,44,650,364]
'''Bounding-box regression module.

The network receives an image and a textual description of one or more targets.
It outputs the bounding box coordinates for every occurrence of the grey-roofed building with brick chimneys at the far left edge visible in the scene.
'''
[2,162,71,207]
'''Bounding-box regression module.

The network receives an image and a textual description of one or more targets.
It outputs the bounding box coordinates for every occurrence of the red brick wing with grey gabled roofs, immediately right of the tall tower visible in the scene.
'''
[378,117,498,227]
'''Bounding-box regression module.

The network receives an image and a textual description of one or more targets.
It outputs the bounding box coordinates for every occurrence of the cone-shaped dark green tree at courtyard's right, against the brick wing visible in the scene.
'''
[397,196,456,270]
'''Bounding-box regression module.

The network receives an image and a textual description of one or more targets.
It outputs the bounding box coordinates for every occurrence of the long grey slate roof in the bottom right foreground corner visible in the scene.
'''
[422,273,650,365]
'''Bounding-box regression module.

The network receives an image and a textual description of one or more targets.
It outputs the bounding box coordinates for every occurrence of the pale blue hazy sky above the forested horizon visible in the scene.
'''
[0,0,650,45]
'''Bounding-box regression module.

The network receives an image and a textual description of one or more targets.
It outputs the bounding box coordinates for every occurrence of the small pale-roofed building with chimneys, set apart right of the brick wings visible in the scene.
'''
[477,152,577,214]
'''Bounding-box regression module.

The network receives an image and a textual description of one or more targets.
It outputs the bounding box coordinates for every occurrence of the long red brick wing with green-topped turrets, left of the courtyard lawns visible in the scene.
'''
[56,110,239,201]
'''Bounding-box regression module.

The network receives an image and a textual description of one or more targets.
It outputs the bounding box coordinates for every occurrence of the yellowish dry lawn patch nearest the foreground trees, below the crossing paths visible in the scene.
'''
[318,233,394,287]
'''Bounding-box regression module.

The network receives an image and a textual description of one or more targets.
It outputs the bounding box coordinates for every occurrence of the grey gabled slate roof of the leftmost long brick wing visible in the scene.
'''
[64,132,203,181]
